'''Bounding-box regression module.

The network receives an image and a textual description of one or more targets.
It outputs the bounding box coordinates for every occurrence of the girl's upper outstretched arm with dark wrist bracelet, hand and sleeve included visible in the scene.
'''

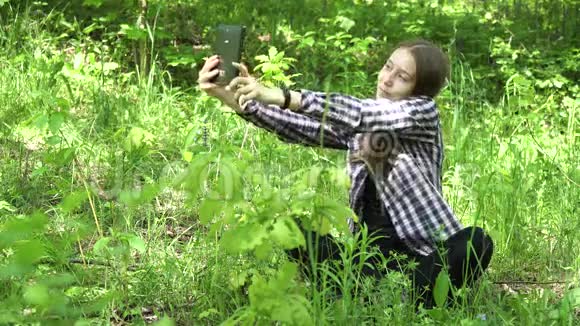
[226,63,439,140]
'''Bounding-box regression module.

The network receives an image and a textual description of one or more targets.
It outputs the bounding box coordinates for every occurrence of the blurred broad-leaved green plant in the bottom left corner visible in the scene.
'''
[0,206,117,324]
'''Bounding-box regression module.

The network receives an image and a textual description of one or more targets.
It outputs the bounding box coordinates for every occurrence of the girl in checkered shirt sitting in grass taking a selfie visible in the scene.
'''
[198,40,493,306]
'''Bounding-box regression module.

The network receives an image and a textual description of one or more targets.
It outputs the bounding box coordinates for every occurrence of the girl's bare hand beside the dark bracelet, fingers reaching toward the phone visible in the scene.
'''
[226,63,284,107]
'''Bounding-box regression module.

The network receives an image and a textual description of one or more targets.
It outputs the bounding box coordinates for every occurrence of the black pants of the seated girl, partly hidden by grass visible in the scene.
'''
[289,227,493,307]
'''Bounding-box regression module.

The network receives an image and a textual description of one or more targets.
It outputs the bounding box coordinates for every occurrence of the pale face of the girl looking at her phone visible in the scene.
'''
[377,48,417,100]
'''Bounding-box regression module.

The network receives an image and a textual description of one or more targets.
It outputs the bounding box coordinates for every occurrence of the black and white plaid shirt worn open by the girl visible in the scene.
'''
[240,90,463,255]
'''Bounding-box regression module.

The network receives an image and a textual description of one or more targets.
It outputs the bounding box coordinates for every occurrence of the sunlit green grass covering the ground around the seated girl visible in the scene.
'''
[0,5,580,325]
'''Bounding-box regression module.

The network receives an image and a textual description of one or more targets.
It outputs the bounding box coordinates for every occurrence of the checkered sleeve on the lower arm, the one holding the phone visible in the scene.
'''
[238,101,348,150]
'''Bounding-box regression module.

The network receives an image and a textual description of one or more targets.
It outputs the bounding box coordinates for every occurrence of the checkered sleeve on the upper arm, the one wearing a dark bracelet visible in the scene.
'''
[299,90,439,138]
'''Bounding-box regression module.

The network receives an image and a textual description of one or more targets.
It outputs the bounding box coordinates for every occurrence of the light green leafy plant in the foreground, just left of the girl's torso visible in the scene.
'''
[175,150,353,324]
